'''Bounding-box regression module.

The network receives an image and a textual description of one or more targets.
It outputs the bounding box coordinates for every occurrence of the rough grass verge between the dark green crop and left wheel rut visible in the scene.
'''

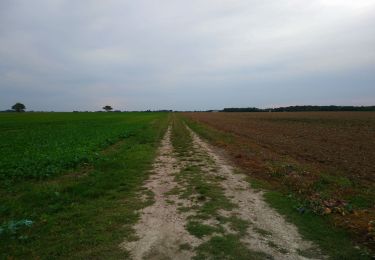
[0,113,167,259]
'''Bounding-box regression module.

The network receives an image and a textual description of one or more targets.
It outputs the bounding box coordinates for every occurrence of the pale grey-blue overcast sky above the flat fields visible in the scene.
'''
[0,0,375,111]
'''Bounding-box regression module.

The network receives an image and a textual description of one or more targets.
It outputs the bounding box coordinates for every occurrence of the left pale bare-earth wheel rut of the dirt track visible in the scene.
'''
[121,127,203,259]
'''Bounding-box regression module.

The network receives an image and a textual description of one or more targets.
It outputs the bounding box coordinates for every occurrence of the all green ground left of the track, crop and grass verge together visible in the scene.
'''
[0,113,168,259]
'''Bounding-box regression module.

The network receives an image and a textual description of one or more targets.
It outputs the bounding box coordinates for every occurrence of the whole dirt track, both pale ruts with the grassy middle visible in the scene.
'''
[121,123,324,259]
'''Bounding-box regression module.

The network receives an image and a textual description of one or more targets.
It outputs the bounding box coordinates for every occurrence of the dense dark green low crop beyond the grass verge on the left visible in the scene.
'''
[0,113,164,183]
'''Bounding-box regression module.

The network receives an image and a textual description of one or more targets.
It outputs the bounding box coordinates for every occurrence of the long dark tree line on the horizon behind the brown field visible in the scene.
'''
[221,106,375,112]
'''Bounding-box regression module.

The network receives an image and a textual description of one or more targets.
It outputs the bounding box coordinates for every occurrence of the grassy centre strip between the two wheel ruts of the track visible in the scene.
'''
[171,116,270,260]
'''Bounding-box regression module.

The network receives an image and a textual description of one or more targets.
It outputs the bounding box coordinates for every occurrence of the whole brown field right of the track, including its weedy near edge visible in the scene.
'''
[185,112,375,251]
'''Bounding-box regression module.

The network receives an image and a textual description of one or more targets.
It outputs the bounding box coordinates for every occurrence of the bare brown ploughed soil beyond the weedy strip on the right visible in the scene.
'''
[187,112,375,183]
